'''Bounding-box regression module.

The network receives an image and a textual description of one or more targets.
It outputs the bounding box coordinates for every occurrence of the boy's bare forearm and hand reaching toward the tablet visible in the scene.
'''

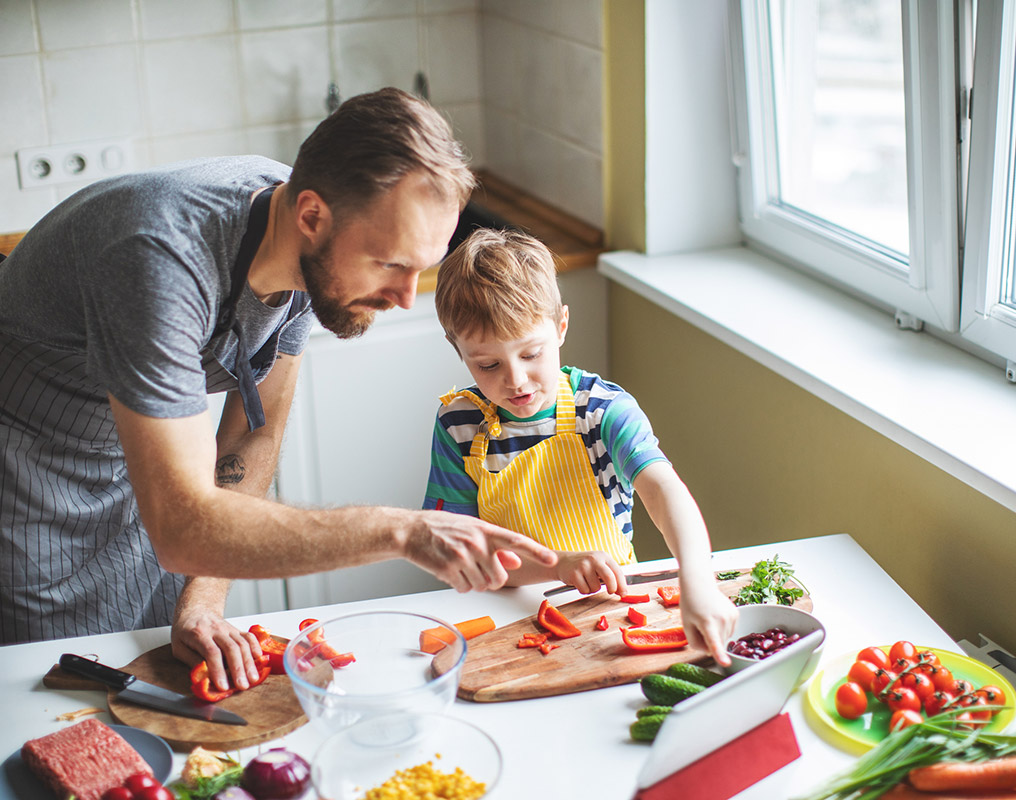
[634,461,738,666]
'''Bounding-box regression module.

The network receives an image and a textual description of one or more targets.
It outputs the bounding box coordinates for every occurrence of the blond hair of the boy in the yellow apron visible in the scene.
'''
[434,228,562,345]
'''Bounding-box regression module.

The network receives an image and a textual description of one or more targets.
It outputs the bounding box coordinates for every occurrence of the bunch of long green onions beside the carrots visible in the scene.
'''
[799,710,1016,800]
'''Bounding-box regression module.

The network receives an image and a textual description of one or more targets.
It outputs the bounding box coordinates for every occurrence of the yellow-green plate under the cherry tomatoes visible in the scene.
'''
[805,647,1016,752]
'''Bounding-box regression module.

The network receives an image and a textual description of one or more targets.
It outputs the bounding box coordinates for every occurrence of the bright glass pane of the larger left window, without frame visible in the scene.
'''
[769,0,909,255]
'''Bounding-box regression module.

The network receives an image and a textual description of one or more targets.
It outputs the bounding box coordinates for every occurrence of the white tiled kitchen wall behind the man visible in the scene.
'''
[0,0,602,232]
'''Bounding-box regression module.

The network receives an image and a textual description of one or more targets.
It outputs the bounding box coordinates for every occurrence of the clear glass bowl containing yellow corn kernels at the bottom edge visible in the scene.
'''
[311,713,501,800]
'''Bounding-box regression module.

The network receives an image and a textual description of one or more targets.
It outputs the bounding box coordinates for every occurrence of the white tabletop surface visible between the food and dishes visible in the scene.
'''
[0,534,983,800]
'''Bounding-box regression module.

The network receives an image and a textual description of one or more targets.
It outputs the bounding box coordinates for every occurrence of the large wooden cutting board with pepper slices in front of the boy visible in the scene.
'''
[458,568,812,702]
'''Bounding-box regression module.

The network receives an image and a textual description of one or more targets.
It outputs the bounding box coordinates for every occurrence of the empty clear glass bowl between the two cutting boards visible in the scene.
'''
[282,611,465,735]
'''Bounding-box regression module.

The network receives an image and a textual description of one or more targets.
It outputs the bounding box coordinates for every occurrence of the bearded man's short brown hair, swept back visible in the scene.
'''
[290,87,475,221]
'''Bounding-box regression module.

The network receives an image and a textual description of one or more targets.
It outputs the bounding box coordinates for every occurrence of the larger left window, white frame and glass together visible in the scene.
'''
[729,0,962,331]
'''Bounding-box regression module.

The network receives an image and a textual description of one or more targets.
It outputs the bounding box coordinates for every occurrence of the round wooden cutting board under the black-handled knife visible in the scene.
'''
[43,644,307,752]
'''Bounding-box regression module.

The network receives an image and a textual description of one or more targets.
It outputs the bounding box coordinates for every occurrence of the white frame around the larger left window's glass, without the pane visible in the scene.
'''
[728,0,962,332]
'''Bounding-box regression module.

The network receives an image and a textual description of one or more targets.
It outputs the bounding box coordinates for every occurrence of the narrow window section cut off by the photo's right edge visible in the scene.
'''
[962,3,1016,363]
